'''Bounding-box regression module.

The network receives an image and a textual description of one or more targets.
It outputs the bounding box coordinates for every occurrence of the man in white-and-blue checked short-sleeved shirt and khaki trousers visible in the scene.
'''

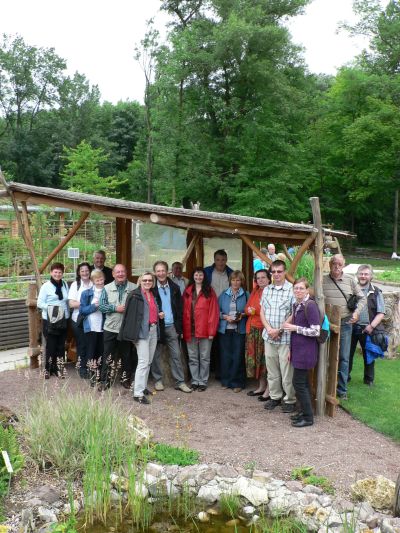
[260,259,296,413]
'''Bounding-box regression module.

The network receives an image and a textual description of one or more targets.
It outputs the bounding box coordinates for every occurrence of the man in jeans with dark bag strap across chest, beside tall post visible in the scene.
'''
[322,254,367,400]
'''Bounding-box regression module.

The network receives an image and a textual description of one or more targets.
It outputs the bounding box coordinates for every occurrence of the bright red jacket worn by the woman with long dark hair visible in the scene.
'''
[183,285,219,341]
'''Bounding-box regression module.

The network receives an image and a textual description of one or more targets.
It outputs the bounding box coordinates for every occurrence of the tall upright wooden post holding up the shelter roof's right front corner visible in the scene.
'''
[310,197,328,416]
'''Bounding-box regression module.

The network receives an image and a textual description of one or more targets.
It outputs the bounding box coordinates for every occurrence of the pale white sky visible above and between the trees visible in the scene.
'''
[0,0,376,103]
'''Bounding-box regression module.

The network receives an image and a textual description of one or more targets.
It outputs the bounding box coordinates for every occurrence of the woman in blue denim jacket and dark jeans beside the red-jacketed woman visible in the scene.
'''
[218,270,248,392]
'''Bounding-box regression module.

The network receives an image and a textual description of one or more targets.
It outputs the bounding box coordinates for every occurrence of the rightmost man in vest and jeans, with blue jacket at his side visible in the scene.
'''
[347,265,385,387]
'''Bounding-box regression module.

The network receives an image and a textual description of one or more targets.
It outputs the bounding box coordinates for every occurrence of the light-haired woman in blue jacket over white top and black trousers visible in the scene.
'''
[79,270,105,387]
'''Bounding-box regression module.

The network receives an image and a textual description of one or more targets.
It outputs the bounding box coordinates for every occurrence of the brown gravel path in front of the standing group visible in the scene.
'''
[0,368,400,493]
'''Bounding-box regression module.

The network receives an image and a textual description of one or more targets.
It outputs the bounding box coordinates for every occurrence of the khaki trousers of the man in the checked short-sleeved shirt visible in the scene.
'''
[265,342,296,403]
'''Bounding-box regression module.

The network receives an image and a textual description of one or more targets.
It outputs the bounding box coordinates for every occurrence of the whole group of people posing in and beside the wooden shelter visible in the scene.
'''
[38,245,384,427]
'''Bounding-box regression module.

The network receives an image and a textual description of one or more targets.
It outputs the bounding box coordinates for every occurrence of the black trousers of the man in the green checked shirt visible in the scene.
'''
[100,331,137,383]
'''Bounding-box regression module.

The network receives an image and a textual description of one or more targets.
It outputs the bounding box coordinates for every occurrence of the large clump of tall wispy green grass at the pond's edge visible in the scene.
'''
[22,391,143,523]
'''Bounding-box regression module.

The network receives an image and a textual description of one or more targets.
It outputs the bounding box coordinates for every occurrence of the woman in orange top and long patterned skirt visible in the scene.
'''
[245,268,271,401]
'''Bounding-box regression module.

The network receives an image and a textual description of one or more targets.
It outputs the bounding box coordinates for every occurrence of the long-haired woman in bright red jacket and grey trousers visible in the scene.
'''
[183,267,219,392]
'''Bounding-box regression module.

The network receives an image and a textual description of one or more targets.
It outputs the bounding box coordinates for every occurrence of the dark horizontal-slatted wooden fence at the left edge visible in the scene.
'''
[0,298,29,350]
